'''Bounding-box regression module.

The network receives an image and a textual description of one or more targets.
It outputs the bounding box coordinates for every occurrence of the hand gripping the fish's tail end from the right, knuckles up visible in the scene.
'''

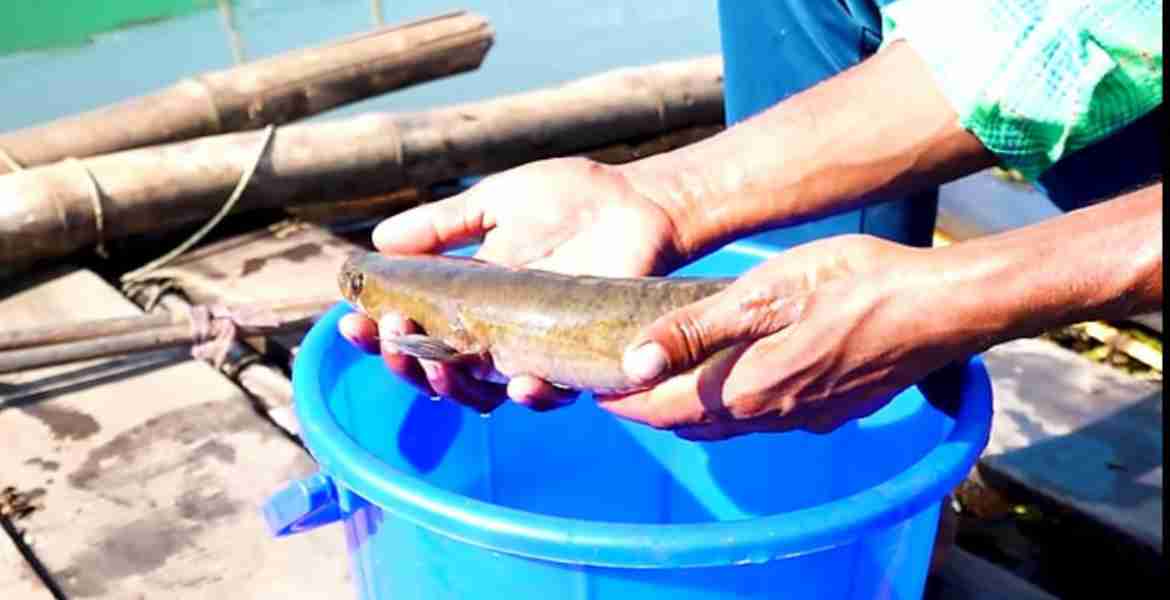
[598,235,978,440]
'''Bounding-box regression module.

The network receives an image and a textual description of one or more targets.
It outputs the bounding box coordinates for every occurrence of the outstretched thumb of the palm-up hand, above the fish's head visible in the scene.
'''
[372,188,491,254]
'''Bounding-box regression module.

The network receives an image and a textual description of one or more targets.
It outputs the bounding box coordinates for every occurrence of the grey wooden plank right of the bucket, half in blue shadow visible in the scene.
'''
[980,339,1163,552]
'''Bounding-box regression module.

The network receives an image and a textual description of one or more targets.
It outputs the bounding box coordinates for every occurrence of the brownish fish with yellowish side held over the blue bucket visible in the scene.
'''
[337,251,735,394]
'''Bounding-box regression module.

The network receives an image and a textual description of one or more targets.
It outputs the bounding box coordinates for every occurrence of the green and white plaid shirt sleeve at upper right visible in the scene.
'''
[882,0,1162,180]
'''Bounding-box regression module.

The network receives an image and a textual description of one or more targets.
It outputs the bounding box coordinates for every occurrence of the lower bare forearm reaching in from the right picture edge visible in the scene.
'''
[925,184,1162,351]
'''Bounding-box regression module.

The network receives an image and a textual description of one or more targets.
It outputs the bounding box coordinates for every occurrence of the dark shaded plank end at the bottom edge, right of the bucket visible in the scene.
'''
[923,549,1057,600]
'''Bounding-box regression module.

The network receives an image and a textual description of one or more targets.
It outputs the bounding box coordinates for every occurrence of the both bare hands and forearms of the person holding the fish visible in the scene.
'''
[340,43,1162,440]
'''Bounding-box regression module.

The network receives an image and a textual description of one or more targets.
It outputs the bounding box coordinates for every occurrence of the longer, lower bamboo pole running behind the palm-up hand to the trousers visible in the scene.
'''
[0,56,723,270]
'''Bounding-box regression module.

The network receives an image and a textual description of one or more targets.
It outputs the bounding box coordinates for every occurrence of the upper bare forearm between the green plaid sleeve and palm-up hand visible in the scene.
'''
[624,43,995,256]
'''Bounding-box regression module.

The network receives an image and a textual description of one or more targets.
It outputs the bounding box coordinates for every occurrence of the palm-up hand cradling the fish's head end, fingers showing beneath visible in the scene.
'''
[339,158,682,413]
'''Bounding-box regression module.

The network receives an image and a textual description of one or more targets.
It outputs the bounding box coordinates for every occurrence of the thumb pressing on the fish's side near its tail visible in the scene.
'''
[621,285,803,384]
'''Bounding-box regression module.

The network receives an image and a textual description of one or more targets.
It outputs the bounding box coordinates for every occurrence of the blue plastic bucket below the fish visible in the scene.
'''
[264,243,991,600]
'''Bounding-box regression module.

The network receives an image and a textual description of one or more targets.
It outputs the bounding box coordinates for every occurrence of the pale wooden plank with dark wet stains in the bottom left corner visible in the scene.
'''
[0,270,352,598]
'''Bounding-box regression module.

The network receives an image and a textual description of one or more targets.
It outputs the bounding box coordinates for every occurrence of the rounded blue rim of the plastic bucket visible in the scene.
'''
[293,240,992,568]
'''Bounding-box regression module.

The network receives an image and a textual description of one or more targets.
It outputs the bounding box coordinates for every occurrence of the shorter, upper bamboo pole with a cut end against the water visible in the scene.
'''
[0,12,493,174]
